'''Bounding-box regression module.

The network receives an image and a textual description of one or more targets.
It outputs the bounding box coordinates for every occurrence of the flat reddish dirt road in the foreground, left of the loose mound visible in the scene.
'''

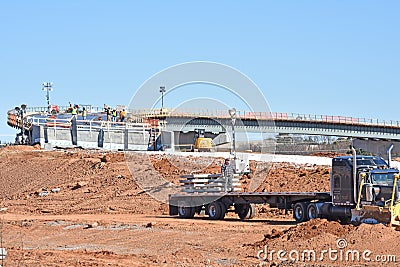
[3,214,293,266]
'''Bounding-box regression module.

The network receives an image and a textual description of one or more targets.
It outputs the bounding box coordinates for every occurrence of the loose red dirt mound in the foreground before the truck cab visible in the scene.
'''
[253,219,400,266]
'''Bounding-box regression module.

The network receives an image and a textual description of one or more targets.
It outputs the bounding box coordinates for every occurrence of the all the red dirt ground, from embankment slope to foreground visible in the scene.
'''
[0,147,400,266]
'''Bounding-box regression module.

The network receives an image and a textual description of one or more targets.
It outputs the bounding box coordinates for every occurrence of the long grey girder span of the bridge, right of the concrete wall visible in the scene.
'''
[151,112,400,140]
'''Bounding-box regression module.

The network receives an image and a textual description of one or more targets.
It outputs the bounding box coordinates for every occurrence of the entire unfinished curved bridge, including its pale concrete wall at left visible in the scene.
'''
[8,106,400,150]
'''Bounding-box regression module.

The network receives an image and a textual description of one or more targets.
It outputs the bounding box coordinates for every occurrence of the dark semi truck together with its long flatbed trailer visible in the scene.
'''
[169,146,400,226]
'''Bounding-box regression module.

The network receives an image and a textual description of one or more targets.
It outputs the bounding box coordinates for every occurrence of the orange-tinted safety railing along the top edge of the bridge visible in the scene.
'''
[9,105,400,127]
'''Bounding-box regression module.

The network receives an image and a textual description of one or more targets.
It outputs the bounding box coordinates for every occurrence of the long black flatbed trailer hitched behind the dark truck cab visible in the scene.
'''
[169,192,331,220]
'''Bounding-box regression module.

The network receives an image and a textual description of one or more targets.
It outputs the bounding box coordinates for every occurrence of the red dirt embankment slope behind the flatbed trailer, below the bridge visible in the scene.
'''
[0,152,329,217]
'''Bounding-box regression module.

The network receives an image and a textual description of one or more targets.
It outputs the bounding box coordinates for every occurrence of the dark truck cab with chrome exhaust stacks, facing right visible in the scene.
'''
[322,155,400,224]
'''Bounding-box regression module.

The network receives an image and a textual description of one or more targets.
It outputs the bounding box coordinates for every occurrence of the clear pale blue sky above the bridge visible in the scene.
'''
[0,0,400,140]
